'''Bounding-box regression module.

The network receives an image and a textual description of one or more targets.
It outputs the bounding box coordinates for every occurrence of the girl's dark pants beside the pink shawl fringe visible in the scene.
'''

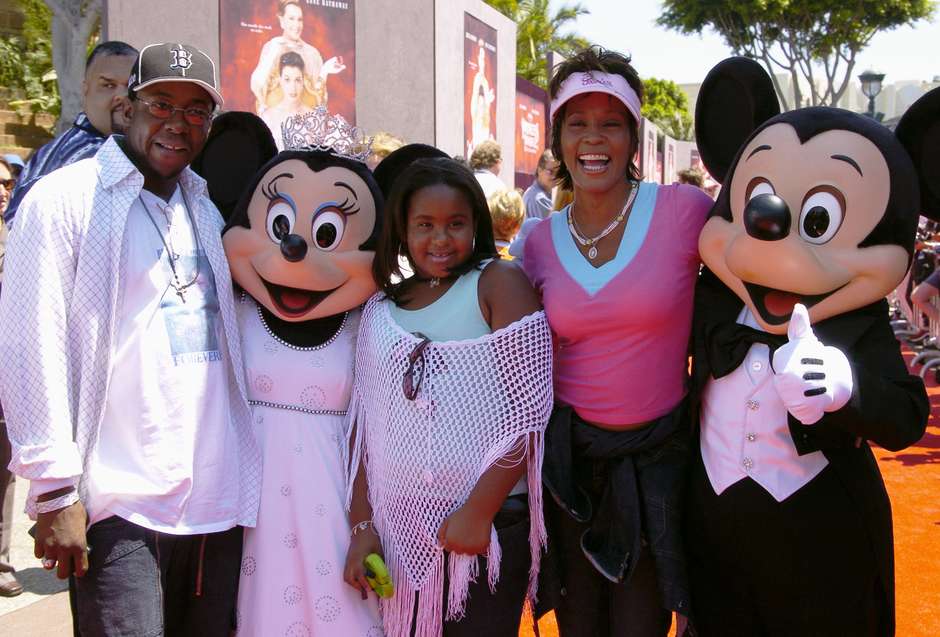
[412,495,532,637]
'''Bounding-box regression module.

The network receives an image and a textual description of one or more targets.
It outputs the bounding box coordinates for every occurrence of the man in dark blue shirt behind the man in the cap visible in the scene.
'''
[3,40,137,225]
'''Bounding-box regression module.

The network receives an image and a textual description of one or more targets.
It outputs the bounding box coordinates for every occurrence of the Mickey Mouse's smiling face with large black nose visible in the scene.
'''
[699,123,908,334]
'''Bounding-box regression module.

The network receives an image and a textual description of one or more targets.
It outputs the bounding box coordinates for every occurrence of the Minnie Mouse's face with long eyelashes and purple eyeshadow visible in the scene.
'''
[222,159,376,321]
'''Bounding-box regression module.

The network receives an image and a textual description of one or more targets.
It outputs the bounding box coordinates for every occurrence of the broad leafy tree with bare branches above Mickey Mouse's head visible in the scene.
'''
[657,0,935,109]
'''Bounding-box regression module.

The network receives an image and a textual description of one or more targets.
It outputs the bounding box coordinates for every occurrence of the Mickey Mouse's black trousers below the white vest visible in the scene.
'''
[686,454,880,637]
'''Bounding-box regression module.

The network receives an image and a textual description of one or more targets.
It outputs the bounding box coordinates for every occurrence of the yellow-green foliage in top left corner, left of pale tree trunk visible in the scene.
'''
[0,0,60,115]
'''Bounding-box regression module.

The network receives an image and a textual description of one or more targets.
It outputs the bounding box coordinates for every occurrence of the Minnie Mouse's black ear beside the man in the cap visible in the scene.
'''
[192,111,277,221]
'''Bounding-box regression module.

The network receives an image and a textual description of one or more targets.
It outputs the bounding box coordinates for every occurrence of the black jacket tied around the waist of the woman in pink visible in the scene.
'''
[542,401,690,615]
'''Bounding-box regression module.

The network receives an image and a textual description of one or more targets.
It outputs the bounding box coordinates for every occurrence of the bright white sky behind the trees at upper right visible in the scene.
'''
[552,0,940,83]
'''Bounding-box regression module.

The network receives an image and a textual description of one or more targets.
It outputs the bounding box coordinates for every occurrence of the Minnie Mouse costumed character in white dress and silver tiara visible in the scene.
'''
[209,109,383,636]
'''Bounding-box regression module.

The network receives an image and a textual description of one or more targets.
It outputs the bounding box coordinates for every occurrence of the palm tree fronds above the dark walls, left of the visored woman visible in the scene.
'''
[486,0,588,89]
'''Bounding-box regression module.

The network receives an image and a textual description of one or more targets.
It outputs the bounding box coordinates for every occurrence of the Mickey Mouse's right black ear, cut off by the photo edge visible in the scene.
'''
[894,88,940,220]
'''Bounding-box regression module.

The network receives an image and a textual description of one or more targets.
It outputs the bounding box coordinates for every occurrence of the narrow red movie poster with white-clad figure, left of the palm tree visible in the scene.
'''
[463,13,496,158]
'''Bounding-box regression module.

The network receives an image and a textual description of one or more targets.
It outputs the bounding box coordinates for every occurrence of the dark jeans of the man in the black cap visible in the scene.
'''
[76,516,243,637]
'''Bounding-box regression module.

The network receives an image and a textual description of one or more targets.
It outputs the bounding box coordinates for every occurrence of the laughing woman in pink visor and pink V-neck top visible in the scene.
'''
[523,48,712,637]
